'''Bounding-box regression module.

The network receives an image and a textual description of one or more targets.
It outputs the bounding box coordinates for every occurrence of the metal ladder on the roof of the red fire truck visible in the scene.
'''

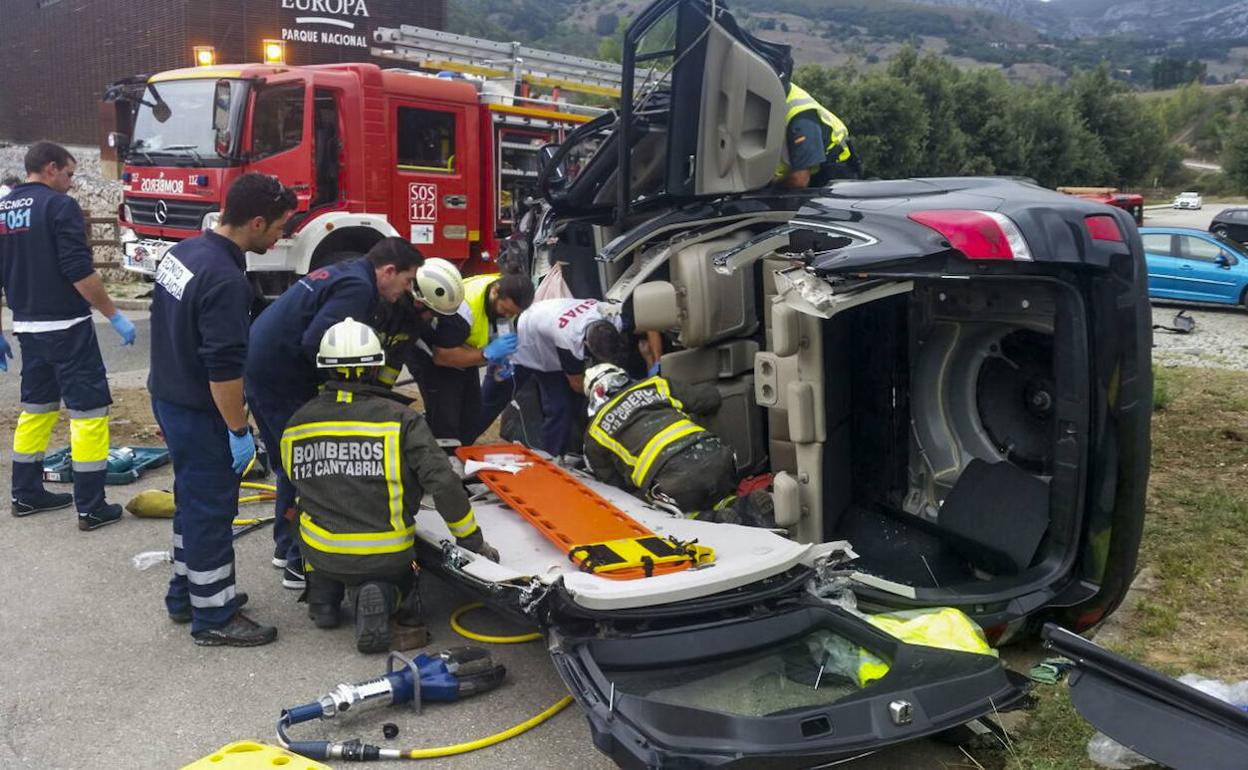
[372,25,623,99]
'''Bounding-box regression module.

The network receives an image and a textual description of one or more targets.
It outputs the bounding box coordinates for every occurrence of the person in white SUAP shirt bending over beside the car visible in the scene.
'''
[473,298,628,457]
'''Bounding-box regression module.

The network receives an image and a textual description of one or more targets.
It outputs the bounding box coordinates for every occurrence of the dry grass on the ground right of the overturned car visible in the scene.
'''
[998,368,1248,770]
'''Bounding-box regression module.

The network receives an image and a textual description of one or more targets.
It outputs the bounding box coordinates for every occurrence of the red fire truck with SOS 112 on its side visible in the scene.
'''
[105,26,619,296]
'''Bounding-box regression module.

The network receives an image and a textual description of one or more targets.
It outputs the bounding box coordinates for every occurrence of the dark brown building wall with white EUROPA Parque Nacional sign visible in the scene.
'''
[0,0,447,145]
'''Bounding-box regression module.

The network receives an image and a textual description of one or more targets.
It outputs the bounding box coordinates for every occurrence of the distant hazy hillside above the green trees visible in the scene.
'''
[449,0,1248,87]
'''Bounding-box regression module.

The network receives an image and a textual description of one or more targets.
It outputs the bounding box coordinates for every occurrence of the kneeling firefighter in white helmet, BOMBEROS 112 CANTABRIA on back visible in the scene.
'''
[281,318,498,653]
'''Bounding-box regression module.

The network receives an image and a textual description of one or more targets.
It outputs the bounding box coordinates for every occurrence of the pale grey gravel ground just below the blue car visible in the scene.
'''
[1153,302,1248,371]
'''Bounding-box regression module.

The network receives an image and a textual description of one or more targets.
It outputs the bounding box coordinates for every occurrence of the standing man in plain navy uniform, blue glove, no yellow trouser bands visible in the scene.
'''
[147,173,297,646]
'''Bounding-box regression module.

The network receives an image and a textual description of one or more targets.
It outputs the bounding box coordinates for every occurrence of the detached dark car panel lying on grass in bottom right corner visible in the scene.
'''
[1041,624,1248,770]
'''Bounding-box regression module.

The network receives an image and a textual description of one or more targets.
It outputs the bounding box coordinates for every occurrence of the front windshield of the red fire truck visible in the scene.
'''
[130,79,243,165]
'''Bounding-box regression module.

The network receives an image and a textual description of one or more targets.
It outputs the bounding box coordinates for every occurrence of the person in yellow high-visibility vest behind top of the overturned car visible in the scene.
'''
[773,85,859,187]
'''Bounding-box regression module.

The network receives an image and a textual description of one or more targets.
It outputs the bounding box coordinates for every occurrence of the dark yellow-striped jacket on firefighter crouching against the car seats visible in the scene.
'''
[585,377,720,490]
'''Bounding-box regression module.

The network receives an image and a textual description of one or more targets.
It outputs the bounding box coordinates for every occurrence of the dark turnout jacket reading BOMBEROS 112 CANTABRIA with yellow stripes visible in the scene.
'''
[282,381,484,575]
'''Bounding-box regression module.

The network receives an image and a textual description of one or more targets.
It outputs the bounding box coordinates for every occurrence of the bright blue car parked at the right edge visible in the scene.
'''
[1139,227,1248,307]
